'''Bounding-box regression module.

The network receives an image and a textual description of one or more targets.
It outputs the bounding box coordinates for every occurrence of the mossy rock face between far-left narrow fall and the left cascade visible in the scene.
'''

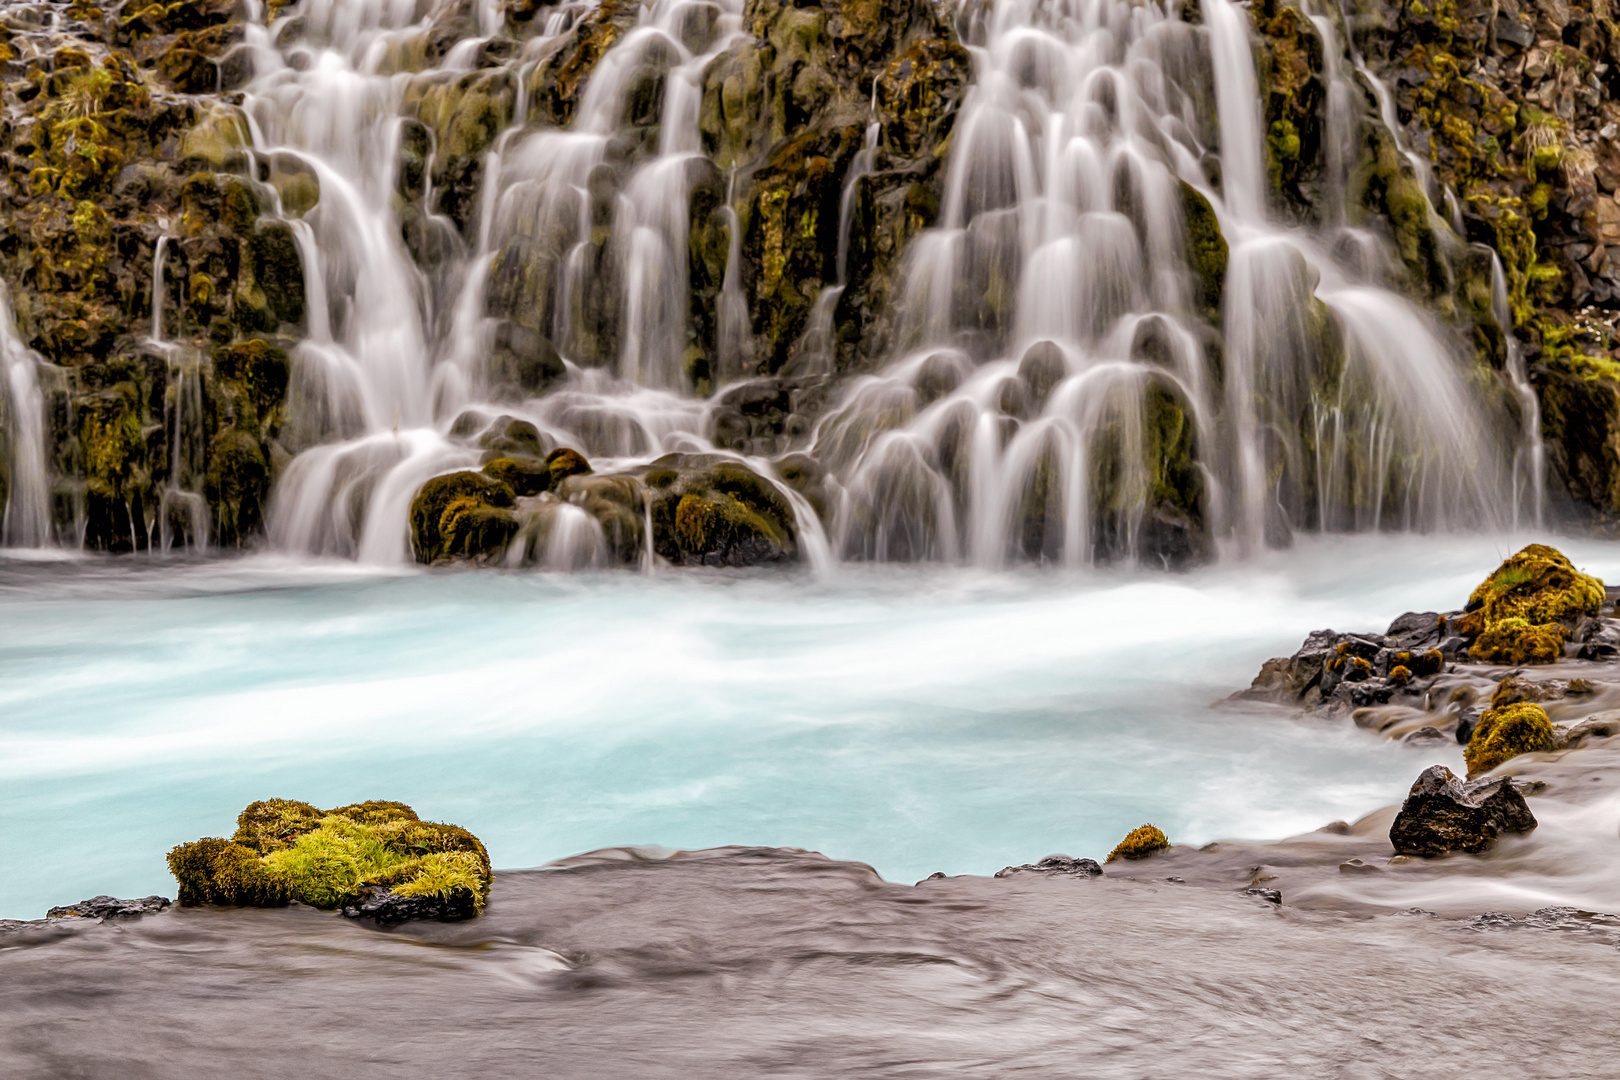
[0,0,305,551]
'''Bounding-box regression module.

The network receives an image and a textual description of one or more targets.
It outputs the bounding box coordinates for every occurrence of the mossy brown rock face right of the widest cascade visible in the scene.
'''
[1334,0,1620,526]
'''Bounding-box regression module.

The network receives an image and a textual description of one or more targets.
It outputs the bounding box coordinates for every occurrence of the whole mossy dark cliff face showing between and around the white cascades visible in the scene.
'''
[9,0,1620,557]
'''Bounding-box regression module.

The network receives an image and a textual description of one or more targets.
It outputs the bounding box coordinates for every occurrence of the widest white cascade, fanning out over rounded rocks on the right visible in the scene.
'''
[816,0,1529,565]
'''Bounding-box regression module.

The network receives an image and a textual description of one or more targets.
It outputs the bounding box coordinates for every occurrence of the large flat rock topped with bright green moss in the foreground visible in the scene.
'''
[168,798,491,921]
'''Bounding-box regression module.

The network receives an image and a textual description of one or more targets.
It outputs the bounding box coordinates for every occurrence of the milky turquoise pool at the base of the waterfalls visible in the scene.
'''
[0,536,1620,918]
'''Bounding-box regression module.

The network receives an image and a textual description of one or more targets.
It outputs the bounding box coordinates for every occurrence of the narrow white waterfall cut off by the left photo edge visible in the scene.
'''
[0,282,52,547]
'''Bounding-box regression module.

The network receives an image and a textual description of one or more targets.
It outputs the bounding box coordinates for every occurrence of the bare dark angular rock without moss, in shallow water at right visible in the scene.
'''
[1390,764,1536,858]
